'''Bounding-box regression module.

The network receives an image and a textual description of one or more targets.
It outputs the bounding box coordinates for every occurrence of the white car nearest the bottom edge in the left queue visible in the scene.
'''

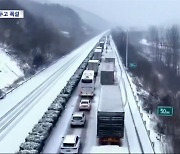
[60,135,80,153]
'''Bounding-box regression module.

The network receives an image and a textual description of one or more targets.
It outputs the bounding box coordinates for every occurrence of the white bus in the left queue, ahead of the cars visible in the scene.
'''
[80,70,95,96]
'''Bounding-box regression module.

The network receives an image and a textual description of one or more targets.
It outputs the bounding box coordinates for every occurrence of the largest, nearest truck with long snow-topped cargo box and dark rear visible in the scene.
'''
[97,85,124,145]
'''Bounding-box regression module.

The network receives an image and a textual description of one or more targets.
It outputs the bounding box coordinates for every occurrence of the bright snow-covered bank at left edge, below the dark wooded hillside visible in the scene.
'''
[0,46,24,89]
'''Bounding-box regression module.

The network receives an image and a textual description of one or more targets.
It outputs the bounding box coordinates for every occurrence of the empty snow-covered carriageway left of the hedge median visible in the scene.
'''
[0,31,103,153]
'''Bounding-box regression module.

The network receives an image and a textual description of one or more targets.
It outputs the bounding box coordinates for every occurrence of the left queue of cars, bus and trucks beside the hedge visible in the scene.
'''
[60,37,106,153]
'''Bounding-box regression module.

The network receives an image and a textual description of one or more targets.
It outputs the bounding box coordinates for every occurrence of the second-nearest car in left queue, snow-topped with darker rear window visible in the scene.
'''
[71,112,86,127]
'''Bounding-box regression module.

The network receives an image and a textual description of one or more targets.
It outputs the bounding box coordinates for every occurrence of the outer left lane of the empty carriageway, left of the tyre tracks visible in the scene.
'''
[0,33,103,117]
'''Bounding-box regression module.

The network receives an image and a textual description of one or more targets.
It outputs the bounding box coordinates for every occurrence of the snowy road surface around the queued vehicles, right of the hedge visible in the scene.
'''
[43,35,154,153]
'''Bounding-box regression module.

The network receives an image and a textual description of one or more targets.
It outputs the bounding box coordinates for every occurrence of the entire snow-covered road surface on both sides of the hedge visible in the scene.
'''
[0,34,157,153]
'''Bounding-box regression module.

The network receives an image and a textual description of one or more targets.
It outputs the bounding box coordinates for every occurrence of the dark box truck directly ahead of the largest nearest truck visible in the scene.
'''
[100,62,115,85]
